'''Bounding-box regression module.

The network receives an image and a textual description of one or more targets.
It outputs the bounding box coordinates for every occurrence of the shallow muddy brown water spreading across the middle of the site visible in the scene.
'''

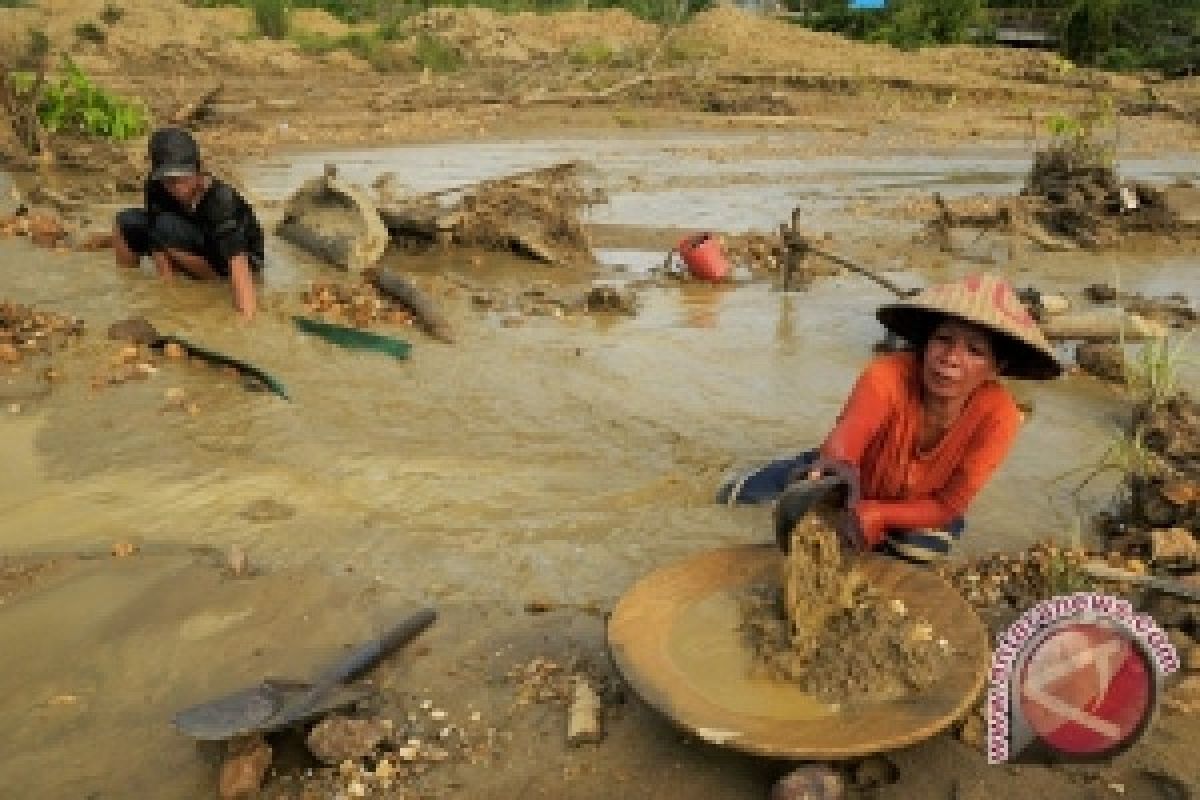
[0,134,1198,796]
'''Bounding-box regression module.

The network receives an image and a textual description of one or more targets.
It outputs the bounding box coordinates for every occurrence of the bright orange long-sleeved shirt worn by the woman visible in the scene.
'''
[821,353,1021,547]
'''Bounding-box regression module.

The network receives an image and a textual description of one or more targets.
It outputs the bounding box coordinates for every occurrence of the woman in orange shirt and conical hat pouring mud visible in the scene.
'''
[718,275,1062,563]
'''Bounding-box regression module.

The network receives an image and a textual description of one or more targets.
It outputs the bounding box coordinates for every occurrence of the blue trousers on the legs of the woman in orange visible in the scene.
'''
[716,450,966,564]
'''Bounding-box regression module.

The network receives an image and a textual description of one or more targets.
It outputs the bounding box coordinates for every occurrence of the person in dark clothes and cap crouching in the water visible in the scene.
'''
[113,128,263,319]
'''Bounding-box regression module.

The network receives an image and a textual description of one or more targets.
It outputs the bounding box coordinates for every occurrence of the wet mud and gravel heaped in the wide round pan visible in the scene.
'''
[740,513,952,704]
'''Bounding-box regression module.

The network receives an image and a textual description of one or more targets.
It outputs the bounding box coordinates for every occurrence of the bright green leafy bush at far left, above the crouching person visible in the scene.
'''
[13,55,149,140]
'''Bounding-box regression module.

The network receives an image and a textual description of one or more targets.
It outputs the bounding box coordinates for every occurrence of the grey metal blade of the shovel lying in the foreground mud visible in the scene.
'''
[174,679,371,741]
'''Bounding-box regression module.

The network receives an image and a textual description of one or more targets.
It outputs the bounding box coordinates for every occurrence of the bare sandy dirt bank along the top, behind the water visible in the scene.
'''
[0,0,1200,190]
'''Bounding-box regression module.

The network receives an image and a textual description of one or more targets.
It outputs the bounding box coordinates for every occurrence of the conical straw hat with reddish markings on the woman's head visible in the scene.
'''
[876,273,1062,380]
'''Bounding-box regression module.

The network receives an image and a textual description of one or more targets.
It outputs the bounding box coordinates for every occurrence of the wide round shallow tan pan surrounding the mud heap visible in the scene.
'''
[608,545,990,759]
